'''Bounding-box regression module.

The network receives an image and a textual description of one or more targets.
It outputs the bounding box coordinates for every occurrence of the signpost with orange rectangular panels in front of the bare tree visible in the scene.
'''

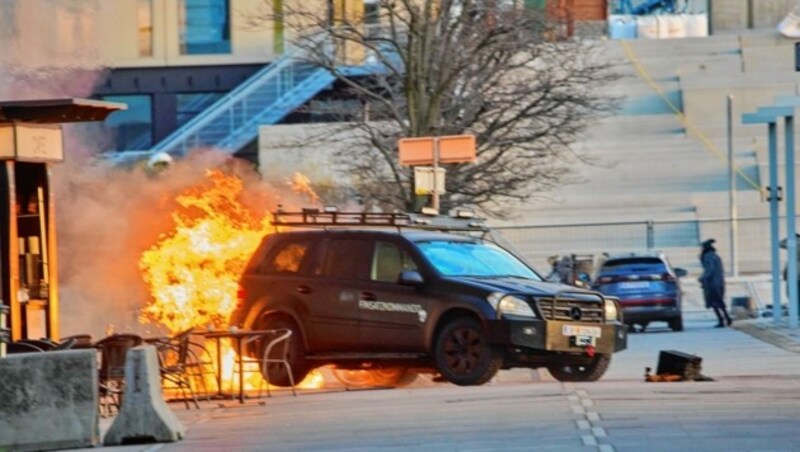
[397,135,477,211]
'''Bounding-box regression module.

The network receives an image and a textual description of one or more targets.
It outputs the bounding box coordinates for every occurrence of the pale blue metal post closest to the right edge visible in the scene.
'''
[784,116,798,328]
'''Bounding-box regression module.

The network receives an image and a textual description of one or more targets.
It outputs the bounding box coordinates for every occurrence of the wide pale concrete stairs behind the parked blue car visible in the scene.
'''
[495,29,800,273]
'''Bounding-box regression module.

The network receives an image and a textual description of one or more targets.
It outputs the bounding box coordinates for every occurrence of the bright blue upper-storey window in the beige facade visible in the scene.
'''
[180,0,231,55]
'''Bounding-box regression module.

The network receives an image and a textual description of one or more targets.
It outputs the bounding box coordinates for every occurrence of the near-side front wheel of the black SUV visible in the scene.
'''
[433,317,502,386]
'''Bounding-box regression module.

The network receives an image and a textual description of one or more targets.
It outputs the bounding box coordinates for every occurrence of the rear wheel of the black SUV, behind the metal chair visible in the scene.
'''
[257,317,311,388]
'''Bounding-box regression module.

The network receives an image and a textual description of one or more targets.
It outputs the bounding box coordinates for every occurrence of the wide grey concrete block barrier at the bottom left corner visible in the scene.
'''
[0,350,99,451]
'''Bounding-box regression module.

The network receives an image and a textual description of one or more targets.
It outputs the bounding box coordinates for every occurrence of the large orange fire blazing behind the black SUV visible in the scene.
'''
[139,170,322,388]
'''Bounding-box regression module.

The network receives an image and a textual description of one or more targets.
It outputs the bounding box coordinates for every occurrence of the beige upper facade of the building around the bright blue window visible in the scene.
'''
[5,0,275,67]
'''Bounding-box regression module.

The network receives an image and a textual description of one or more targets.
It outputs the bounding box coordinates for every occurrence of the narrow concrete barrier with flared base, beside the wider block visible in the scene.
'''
[103,345,184,446]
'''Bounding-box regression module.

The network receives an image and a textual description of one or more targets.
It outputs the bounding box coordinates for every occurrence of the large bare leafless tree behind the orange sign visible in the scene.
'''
[244,0,617,217]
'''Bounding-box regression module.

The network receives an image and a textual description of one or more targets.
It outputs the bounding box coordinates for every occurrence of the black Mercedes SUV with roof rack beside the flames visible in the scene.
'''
[231,210,627,386]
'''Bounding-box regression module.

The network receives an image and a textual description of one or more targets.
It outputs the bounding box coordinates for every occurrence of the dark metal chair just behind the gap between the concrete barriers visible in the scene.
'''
[94,334,142,416]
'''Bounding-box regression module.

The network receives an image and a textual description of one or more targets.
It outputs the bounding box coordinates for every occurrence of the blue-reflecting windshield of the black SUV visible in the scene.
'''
[418,240,542,281]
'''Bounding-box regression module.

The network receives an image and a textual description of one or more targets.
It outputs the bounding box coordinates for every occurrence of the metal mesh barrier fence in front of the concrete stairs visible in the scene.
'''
[493,217,786,274]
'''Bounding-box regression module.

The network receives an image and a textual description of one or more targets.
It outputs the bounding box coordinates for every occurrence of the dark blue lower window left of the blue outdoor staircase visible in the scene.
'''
[103,95,153,151]
